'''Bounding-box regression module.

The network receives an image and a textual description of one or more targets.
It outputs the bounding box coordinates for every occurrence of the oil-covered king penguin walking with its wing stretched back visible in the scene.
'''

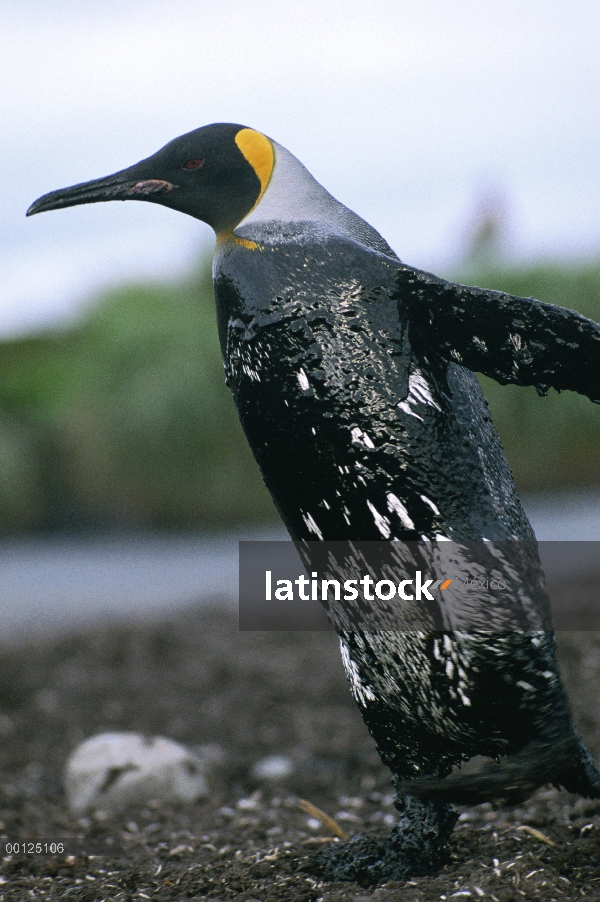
[27,124,600,883]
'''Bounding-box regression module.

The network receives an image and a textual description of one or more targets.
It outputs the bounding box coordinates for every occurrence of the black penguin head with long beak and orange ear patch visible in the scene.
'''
[27,123,275,235]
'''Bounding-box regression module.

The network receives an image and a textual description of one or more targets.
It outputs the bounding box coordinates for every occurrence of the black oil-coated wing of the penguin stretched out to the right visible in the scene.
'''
[397,267,600,404]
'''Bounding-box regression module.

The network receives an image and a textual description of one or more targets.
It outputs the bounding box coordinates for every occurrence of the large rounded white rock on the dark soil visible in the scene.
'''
[65,733,209,814]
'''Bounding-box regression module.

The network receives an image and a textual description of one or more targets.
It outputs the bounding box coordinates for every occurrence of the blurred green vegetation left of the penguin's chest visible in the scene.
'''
[0,261,276,534]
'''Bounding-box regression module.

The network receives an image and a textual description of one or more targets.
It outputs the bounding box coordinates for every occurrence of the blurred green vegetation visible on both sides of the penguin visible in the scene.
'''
[0,261,600,534]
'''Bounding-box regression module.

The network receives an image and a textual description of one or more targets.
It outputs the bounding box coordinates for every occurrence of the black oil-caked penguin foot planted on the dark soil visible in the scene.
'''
[308,796,458,886]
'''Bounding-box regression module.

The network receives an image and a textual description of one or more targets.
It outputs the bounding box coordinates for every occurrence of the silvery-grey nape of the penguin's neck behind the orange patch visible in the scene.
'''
[233,141,398,260]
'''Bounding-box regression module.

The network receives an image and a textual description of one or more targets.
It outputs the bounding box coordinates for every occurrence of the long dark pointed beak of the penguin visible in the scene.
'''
[25,167,177,216]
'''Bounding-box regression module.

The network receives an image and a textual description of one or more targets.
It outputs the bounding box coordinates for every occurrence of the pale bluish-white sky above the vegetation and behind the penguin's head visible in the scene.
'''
[0,0,600,335]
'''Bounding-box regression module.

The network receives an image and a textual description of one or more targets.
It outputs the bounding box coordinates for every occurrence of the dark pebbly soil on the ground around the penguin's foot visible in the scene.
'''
[0,586,600,902]
